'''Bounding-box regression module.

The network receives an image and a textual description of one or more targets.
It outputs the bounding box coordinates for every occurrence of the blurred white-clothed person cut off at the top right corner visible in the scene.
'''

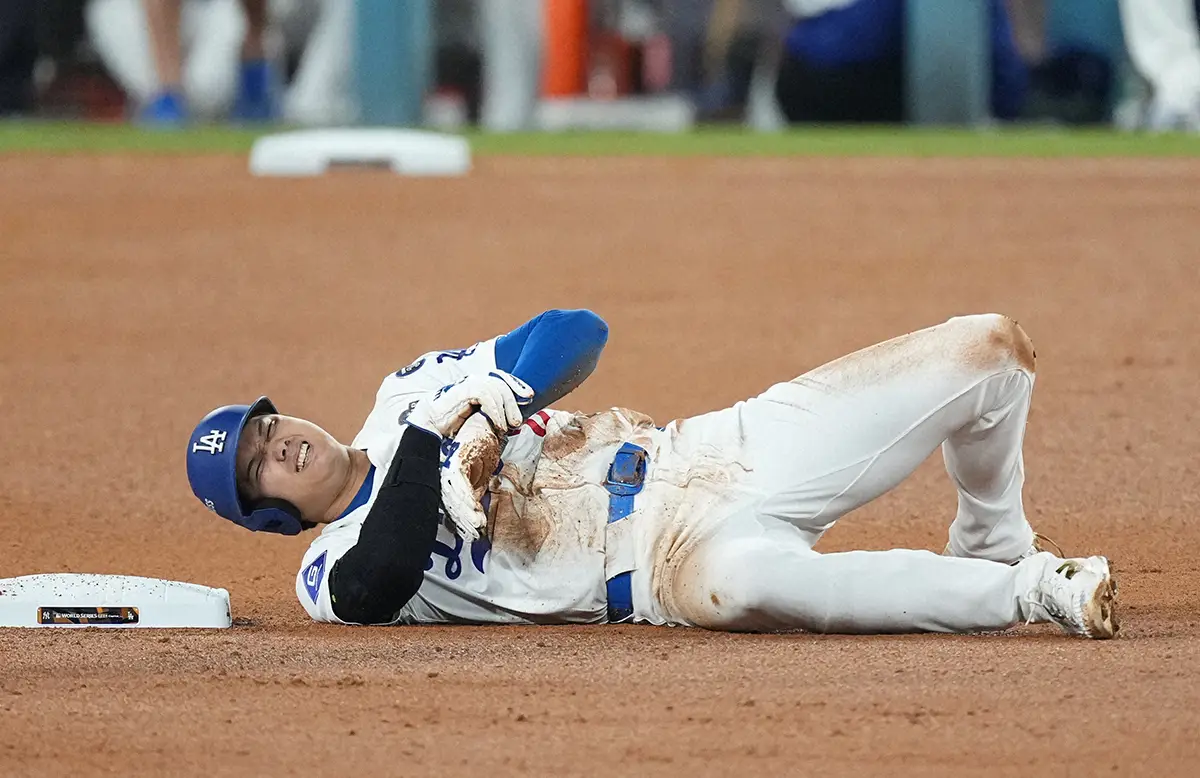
[1121,0,1200,132]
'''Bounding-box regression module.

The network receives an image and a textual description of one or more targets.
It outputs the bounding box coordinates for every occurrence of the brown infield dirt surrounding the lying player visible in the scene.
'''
[0,156,1200,778]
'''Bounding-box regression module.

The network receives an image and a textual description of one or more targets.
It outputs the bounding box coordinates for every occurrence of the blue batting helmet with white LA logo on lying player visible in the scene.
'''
[187,396,304,534]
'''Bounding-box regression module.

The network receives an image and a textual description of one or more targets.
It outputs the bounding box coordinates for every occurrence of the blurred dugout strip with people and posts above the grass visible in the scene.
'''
[0,0,1200,132]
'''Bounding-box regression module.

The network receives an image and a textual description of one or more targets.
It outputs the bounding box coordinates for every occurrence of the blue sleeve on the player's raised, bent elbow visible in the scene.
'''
[496,310,608,418]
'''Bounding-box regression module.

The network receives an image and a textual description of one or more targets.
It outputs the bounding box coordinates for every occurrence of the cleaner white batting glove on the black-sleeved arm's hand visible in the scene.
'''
[408,370,534,437]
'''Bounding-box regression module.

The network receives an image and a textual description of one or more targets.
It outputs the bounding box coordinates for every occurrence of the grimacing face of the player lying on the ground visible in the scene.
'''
[238,413,350,521]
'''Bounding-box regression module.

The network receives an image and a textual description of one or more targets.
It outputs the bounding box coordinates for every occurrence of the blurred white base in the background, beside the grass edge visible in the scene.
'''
[250,127,470,176]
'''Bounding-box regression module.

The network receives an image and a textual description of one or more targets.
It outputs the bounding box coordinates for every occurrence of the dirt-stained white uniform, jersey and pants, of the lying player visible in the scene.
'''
[296,315,1046,633]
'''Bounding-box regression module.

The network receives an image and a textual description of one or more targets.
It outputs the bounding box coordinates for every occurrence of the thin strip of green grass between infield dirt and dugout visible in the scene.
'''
[0,121,1200,157]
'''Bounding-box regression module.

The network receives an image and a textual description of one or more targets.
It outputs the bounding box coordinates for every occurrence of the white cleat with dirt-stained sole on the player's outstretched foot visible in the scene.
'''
[1025,552,1121,640]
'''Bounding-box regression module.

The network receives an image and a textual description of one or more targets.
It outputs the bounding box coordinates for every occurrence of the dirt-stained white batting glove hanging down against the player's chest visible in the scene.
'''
[442,413,500,540]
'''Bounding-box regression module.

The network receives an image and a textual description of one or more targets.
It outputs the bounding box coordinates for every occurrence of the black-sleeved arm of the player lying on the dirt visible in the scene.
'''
[329,426,442,624]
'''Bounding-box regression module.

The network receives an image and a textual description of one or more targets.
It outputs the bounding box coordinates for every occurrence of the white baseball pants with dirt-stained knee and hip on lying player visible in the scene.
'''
[657,315,1060,633]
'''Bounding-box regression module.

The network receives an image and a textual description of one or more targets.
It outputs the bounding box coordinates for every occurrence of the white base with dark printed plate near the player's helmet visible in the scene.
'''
[0,573,233,629]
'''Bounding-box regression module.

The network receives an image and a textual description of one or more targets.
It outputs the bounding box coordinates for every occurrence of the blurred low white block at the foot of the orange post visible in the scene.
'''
[534,95,696,132]
